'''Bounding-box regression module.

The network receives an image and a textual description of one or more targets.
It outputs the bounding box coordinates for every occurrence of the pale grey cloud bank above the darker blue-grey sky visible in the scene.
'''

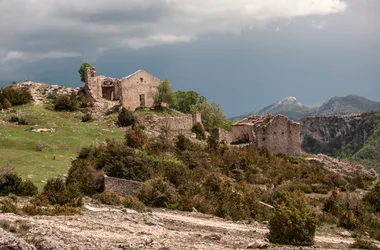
[0,0,347,71]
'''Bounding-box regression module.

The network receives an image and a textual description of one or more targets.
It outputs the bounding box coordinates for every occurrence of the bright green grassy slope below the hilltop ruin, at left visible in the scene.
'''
[0,105,125,188]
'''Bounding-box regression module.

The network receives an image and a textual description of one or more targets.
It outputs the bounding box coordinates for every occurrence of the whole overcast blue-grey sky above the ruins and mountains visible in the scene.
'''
[0,0,380,116]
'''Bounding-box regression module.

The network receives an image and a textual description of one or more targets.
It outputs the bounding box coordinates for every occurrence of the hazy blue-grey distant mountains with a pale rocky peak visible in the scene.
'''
[231,95,380,121]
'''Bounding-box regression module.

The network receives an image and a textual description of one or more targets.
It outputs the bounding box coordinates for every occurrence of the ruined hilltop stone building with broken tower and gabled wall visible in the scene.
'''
[84,67,161,111]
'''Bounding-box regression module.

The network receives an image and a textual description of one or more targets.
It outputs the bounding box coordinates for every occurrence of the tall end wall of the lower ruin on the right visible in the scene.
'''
[254,115,301,155]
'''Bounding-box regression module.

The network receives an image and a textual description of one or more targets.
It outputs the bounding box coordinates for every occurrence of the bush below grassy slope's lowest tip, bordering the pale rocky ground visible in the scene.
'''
[42,178,82,206]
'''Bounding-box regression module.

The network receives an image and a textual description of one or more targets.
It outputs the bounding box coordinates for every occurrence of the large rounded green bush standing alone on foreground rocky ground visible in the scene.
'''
[269,192,317,246]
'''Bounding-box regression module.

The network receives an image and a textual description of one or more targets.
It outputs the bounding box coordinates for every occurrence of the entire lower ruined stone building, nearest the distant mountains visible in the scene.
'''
[232,115,301,155]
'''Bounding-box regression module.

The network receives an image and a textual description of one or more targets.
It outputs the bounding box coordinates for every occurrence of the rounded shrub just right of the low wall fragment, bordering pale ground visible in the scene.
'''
[138,177,179,208]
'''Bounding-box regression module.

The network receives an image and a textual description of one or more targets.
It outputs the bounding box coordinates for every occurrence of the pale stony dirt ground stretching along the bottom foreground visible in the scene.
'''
[0,204,378,250]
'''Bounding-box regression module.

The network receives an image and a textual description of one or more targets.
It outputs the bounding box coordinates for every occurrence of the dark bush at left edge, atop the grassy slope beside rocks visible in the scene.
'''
[0,87,32,106]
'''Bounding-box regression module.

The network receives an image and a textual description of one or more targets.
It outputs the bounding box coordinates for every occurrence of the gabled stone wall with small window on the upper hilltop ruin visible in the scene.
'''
[121,70,161,111]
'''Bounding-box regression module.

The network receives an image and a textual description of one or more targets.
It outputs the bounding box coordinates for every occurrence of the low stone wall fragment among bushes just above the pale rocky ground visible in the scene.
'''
[104,176,142,196]
